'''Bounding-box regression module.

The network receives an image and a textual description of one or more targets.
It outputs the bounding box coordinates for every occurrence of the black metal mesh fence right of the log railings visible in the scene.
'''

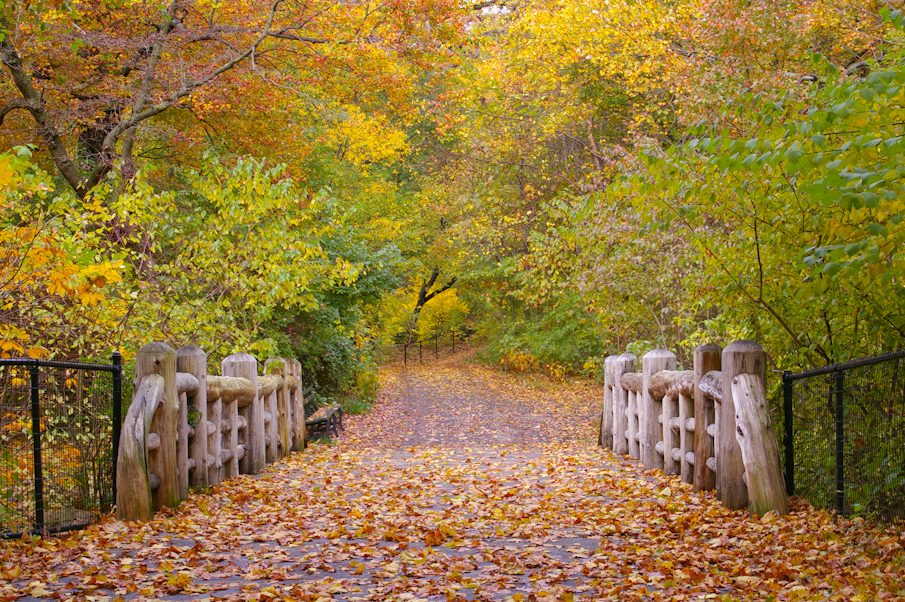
[782,350,905,520]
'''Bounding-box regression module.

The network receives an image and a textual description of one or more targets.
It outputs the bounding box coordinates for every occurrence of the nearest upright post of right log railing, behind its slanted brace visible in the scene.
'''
[716,341,767,510]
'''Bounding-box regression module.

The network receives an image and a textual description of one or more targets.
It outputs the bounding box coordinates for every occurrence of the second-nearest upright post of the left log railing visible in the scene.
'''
[176,345,207,487]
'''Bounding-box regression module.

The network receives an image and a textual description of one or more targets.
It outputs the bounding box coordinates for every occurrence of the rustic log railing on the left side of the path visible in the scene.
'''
[116,343,305,520]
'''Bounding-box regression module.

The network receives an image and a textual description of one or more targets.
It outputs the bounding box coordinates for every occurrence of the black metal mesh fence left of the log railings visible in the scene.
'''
[0,353,122,538]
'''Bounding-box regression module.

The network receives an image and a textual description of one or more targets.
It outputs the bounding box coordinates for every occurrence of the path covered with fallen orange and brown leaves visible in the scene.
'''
[0,350,905,602]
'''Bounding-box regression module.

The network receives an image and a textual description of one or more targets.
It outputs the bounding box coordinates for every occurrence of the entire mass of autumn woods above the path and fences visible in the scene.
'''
[0,0,905,391]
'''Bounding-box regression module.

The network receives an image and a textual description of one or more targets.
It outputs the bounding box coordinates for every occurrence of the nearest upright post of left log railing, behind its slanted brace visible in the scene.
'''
[134,343,180,510]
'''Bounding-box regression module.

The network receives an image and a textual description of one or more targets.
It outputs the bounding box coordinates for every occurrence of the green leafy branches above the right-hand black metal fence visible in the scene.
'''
[619,51,905,366]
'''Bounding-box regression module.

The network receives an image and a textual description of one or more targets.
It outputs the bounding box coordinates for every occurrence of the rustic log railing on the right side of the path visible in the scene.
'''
[599,341,788,515]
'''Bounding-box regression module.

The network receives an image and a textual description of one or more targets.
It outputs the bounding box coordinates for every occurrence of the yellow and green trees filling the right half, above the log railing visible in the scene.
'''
[426,0,905,372]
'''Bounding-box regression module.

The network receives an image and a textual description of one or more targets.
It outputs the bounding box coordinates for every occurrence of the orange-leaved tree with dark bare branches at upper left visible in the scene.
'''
[0,0,460,197]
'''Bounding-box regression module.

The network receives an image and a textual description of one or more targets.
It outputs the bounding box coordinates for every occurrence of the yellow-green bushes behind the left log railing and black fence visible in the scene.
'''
[0,148,398,398]
